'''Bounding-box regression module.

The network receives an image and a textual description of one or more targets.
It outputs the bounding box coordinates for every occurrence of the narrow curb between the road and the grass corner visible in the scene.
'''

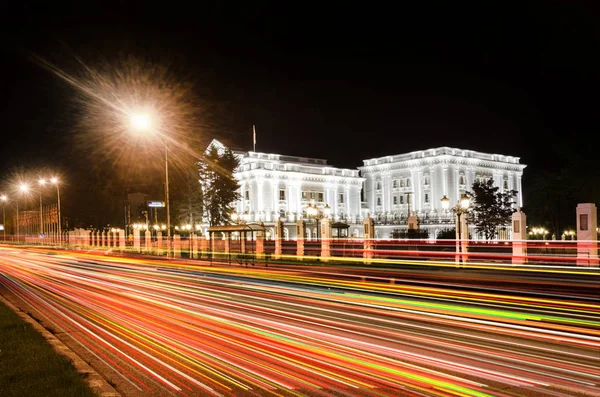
[0,295,122,397]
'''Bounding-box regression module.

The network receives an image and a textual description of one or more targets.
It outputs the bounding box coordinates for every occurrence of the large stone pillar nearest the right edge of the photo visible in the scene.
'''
[577,203,598,267]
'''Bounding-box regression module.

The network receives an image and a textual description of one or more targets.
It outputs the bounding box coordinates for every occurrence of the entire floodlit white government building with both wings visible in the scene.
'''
[211,140,526,239]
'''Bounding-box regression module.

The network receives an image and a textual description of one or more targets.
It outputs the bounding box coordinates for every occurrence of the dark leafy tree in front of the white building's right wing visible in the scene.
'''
[471,178,517,240]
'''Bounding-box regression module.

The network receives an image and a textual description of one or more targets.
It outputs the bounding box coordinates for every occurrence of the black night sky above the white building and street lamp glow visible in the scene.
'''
[0,1,600,178]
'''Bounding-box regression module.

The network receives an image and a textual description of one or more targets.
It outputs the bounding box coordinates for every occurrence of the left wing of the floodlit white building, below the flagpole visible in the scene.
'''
[211,140,364,238]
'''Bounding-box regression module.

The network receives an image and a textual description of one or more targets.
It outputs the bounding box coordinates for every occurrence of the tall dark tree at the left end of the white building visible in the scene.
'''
[198,145,240,226]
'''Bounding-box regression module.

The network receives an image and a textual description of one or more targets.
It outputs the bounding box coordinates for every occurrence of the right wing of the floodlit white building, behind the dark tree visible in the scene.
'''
[359,147,526,238]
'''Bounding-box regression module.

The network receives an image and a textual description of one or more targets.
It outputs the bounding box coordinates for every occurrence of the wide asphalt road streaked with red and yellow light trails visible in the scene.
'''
[0,248,600,396]
